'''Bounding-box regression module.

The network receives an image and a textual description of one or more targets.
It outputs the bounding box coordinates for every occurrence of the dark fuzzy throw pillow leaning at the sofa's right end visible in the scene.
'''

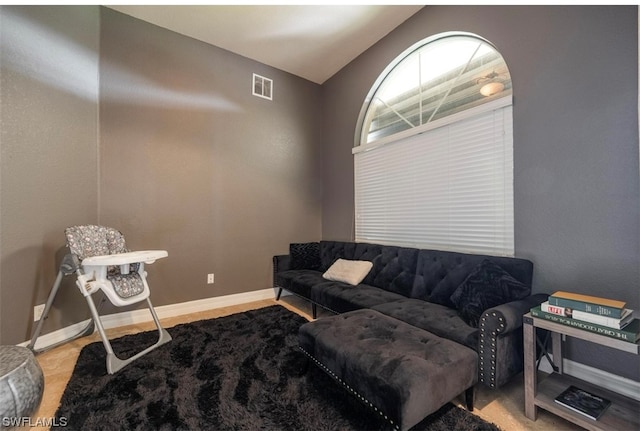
[451,259,531,328]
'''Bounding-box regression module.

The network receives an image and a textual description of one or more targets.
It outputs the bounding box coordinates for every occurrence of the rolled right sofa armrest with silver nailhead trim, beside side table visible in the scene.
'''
[478,293,548,388]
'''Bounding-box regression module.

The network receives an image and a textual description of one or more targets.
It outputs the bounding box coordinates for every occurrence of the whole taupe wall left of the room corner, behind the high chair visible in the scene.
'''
[0,6,322,344]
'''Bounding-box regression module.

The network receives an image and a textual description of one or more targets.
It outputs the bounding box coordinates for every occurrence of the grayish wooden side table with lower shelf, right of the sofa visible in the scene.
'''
[523,313,640,431]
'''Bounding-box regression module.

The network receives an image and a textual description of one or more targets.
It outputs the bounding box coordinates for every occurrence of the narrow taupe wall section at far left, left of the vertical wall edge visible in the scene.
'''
[0,6,99,344]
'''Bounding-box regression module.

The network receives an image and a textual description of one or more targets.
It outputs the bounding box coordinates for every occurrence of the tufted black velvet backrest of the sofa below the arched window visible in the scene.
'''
[320,241,533,307]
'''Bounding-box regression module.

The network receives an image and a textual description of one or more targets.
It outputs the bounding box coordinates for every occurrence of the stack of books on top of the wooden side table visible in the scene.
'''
[531,291,640,343]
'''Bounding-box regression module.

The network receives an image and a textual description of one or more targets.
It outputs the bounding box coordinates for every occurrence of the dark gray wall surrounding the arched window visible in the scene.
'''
[322,6,640,380]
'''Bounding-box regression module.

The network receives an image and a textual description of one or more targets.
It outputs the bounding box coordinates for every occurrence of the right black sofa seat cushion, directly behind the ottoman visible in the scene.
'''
[371,298,479,350]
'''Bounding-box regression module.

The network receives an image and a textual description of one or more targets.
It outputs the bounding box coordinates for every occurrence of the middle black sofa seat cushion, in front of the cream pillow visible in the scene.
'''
[311,280,404,313]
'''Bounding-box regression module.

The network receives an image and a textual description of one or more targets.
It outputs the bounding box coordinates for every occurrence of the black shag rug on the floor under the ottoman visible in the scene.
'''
[54,305,498,431]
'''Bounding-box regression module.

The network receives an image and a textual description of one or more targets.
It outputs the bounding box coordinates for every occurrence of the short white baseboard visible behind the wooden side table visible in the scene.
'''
[539,354,640,401]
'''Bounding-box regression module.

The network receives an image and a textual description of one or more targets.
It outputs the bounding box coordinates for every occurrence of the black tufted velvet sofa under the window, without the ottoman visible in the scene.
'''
[273,241,547,388]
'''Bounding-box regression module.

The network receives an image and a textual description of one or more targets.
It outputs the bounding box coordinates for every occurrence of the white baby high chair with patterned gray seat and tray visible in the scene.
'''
[28,225,171,374]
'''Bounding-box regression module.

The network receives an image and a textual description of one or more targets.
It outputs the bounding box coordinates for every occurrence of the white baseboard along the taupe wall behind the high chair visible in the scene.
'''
[19,288,275,350]
